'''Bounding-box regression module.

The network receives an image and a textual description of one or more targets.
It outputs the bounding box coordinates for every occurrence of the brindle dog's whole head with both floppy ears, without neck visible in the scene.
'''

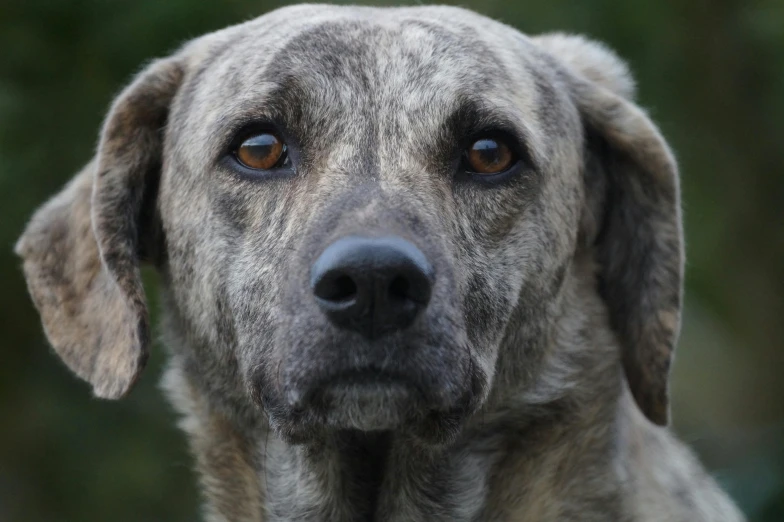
[17,6,682,440]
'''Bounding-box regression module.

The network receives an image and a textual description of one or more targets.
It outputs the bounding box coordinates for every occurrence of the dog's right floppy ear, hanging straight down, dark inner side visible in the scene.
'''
[536,35,683,425]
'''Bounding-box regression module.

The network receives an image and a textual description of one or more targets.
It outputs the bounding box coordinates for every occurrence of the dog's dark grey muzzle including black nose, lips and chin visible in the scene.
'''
[258,227,482,440]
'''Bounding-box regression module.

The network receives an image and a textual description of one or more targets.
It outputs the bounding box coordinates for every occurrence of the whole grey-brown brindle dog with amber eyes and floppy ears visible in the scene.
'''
[16,5,743,522]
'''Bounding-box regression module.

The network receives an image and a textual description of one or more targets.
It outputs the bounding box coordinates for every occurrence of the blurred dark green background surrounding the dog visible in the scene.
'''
[0,0,784,522]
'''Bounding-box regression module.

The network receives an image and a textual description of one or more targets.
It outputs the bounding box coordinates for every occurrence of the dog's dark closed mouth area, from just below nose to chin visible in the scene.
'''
[264,316,487,443]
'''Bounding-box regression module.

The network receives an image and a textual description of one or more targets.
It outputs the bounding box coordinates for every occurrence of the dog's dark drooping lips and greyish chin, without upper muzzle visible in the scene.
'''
[253,352,486,444]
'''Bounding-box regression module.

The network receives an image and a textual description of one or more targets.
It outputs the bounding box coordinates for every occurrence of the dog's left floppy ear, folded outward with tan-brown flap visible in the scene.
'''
[16,58,183,399]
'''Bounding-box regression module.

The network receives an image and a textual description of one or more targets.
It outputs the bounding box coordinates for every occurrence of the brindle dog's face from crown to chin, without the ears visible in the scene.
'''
[160,8,582,433]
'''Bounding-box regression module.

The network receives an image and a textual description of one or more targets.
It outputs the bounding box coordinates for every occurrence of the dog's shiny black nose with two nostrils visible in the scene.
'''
[310,237,434,338]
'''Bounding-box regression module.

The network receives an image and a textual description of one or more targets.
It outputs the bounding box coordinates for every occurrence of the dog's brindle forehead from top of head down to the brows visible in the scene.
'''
[183,6,534,120]
